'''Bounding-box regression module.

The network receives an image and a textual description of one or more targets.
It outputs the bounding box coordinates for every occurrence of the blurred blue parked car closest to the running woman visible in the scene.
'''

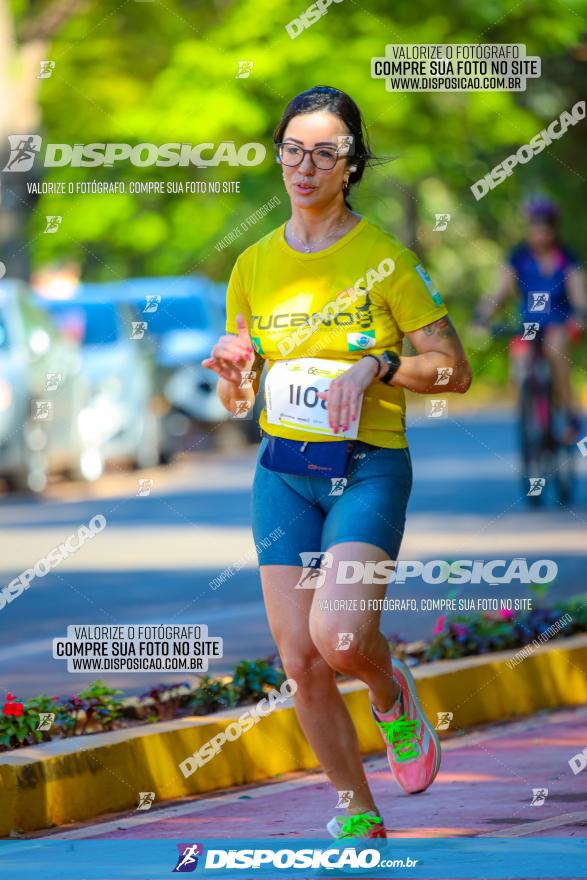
[99,276,230,459]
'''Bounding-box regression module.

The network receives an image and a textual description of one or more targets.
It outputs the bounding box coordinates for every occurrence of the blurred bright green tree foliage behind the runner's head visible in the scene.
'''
[6,0,587,322]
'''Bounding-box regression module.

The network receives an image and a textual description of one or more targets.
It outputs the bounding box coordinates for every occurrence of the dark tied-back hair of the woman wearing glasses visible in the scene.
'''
[273,86,375,208]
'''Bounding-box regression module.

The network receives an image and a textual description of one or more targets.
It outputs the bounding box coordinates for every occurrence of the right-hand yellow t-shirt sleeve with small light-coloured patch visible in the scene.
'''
[390,250,448,333]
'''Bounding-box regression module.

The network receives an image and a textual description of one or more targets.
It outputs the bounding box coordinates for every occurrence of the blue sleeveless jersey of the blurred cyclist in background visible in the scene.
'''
[508,243,577,326]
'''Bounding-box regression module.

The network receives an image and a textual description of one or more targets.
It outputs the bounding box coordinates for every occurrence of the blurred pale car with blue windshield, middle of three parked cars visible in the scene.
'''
[37,284,160,480]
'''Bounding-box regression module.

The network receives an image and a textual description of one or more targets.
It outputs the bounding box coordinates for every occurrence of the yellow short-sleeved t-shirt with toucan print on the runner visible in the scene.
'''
[226,218,447,448]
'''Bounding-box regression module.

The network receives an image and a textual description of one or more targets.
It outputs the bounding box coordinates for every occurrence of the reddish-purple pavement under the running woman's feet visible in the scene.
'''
[39,707,587,840]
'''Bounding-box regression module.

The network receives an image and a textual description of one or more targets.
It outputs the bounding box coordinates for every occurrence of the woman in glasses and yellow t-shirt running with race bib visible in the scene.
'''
[203,87,471,838]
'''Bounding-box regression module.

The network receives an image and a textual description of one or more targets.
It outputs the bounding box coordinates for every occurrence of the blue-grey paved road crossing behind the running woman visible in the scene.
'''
[0,412,587,698]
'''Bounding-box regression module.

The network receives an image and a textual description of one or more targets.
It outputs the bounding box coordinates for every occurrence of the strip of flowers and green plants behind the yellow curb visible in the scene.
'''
[0,596,587,751]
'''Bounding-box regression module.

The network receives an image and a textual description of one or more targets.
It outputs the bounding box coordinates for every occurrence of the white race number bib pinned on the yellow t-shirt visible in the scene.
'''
[265,358,363,440]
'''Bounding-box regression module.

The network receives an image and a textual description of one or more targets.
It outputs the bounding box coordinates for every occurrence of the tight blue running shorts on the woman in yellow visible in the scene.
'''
[252,437,412,566]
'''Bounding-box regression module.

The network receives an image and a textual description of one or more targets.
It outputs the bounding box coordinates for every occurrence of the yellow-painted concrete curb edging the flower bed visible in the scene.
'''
[0,635,587,836]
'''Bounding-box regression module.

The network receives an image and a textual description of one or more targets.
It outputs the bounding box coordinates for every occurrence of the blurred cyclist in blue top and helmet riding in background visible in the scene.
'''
[479,196,587,443]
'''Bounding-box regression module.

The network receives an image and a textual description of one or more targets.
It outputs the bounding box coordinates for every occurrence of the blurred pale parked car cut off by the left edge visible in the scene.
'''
[0,280,81,492]
